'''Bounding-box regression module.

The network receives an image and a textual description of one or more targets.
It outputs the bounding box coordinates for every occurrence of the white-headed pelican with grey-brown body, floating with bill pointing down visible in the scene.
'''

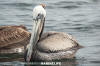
[25,4,82,62]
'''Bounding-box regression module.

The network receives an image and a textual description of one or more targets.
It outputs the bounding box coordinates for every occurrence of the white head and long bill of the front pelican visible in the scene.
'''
[26,4,46,62]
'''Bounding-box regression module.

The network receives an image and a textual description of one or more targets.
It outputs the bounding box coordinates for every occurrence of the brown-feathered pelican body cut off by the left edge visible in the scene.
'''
[0,25,31,53]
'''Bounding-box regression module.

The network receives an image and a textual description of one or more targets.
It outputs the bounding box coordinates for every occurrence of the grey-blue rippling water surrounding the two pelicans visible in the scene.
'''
[0,0,100,66]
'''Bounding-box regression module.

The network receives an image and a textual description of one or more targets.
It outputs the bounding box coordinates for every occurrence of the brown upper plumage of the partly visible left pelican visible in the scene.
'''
[0,25,30,48]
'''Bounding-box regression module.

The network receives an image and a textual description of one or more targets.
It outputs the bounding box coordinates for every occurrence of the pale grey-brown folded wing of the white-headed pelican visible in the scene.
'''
[37,32,78,52]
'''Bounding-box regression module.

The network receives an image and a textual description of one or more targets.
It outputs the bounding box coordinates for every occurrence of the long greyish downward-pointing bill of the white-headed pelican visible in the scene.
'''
[26,14,45,62]
